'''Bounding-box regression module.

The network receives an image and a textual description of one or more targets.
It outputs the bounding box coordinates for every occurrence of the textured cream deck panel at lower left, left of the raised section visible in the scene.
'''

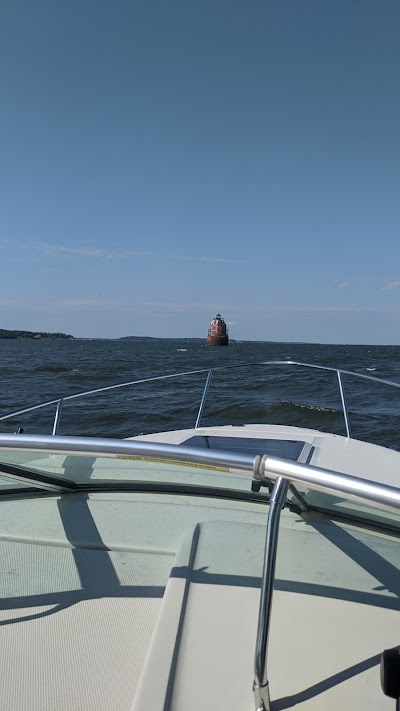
[0,494,265,711]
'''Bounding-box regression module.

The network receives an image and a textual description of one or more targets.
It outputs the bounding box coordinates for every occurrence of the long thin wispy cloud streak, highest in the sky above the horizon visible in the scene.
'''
[32,242,244,264]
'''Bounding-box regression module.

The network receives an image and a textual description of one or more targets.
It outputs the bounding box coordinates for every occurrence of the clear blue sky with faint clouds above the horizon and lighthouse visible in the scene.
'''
[0,0,400,344]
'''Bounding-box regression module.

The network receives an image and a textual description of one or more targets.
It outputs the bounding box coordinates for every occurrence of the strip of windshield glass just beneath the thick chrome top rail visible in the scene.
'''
[0,449,400,532]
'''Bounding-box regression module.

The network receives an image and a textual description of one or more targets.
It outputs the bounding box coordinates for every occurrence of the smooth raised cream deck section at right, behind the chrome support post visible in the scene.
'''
[134,516,400,711]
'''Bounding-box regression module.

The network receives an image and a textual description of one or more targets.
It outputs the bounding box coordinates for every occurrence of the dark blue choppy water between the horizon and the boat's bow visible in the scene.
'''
[0,339,400,448]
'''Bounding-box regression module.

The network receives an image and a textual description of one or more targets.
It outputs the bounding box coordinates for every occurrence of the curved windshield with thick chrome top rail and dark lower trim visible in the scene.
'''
[0,435,400,533]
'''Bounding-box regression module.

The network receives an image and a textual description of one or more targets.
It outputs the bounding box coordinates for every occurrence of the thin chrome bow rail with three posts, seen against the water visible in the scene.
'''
[0,360,400,437]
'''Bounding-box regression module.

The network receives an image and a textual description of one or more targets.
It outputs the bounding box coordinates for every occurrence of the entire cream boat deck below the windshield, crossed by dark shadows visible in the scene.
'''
[0,494,400,711]
